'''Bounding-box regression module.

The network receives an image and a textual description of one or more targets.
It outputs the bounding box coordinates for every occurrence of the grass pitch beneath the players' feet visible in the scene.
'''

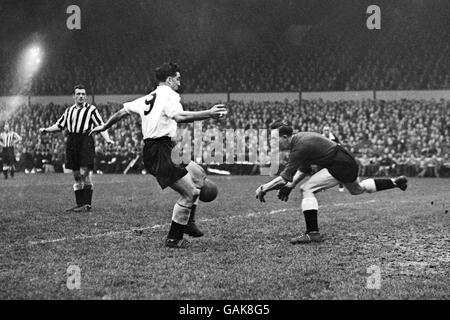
[0,174,450,300]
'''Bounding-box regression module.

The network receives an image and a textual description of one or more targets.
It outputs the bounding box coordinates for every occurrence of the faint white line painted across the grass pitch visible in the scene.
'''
[28,200,376,246]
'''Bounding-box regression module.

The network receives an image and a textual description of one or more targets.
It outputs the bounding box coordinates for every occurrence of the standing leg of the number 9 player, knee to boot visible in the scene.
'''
[166,173,200,248]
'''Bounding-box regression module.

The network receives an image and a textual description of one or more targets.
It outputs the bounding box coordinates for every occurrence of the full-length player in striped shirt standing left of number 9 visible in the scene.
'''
[39,85,114,212]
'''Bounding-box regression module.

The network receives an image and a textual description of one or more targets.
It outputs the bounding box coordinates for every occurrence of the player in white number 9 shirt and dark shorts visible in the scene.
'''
[91,63,227,248]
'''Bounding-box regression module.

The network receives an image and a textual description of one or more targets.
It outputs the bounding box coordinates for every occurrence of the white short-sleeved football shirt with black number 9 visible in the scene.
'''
[123,85,183,140]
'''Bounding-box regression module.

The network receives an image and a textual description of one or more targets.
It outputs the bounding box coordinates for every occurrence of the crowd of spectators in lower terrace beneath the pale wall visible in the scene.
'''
[0,100,450,177]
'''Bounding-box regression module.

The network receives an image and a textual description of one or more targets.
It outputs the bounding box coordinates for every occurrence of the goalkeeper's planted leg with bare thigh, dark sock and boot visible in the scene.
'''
[291,169,339,244]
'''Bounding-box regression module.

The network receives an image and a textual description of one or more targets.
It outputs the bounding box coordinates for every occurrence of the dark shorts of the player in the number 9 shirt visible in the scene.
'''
[143,136,188,189]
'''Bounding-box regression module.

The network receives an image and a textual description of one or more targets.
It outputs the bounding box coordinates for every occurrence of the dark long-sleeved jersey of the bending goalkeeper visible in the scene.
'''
[281,132,338,181]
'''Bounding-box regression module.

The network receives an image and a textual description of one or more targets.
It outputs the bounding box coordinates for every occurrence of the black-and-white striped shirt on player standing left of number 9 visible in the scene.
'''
[56,103,103,133]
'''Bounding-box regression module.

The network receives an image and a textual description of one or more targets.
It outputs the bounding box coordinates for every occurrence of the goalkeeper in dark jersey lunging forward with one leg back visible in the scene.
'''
[256,124,407,244]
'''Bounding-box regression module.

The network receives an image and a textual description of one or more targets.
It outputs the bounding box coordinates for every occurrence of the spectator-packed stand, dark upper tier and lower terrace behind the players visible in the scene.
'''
[0,0,450,176]
